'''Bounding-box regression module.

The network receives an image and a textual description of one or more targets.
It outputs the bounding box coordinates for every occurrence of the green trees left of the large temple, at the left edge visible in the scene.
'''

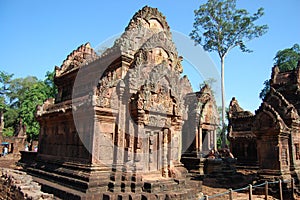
[0,71,57,141]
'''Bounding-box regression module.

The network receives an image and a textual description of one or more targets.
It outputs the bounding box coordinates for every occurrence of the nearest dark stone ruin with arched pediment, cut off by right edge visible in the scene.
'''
[253,62,300,180]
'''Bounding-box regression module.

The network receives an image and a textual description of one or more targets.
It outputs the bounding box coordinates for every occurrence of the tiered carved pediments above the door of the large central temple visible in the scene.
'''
[96,6,192,120]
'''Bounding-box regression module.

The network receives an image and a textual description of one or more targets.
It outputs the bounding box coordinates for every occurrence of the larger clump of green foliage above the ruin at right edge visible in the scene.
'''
[274,44,300,72]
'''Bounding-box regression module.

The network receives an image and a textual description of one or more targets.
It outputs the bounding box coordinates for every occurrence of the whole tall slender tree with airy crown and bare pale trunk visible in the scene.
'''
[190,0,268,146]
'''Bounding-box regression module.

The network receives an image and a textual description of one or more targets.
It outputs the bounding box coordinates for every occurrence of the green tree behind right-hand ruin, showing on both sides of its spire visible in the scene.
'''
[259,44,300,99]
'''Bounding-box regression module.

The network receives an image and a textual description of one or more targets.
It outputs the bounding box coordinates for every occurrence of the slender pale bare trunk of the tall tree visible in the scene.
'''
[221,56,226,148]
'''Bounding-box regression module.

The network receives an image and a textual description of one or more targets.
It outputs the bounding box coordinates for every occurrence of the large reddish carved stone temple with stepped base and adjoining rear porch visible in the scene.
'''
[20,6,218,199]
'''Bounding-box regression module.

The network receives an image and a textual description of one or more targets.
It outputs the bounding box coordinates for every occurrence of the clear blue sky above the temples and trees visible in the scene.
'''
[0,0,300,112]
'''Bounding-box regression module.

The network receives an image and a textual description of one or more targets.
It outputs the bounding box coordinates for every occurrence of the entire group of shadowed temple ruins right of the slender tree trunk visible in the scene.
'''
[229,62,300,182]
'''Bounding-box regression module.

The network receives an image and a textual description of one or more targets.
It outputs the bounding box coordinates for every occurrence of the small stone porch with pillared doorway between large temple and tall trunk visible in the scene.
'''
[181,85,219,174]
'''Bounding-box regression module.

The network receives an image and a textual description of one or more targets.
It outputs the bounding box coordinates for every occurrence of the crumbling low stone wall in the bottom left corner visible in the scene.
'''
[0,168,55,200]
